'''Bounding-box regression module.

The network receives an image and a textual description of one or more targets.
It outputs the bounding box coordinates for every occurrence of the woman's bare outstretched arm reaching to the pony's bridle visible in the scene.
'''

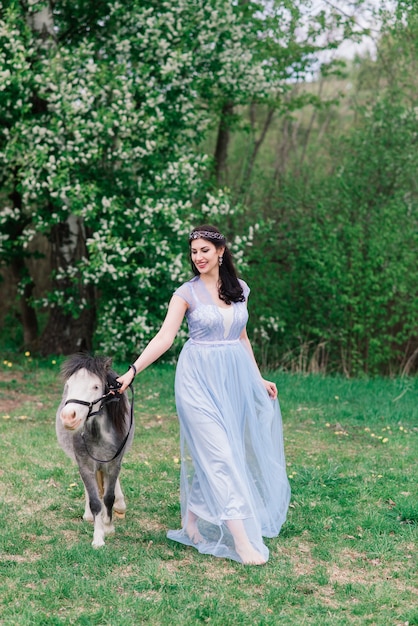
[117,296,188,393]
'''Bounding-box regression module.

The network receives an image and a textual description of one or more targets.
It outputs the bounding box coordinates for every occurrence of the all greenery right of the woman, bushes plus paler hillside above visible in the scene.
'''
[230,2,418,375]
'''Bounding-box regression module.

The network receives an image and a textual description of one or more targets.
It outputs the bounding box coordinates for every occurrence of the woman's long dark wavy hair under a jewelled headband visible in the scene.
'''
[189,224,245,304]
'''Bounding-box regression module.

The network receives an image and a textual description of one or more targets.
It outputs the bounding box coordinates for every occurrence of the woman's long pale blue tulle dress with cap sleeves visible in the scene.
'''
[167,276,290,562]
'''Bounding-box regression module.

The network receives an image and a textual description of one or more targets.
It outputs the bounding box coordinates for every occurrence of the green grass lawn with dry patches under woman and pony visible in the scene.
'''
[0,358,418,626]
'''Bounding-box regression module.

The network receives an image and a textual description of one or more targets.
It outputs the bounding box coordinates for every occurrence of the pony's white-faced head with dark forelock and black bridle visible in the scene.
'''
[60,353,127,432]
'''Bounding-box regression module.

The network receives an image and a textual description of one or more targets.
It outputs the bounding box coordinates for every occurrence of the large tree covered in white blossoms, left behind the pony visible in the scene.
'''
[0,0,366,357]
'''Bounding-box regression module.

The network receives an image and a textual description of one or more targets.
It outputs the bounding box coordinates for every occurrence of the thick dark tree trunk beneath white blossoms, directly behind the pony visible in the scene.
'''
[40,216,96,356]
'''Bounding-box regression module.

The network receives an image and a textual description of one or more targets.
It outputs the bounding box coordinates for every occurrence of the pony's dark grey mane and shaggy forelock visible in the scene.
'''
[61,352,129,434]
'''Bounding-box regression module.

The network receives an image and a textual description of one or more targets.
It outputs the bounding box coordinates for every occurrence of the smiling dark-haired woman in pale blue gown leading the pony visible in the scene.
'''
[118,225,290,565]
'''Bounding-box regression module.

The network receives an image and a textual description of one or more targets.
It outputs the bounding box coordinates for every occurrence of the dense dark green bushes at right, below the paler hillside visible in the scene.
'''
[243,92,418,375]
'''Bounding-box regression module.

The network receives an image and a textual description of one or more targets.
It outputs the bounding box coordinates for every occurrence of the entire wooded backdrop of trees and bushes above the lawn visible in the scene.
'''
[0,0,418,376]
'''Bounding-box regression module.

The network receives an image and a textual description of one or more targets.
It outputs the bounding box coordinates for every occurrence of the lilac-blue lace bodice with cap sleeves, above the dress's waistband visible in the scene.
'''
[174,276,250,342]
